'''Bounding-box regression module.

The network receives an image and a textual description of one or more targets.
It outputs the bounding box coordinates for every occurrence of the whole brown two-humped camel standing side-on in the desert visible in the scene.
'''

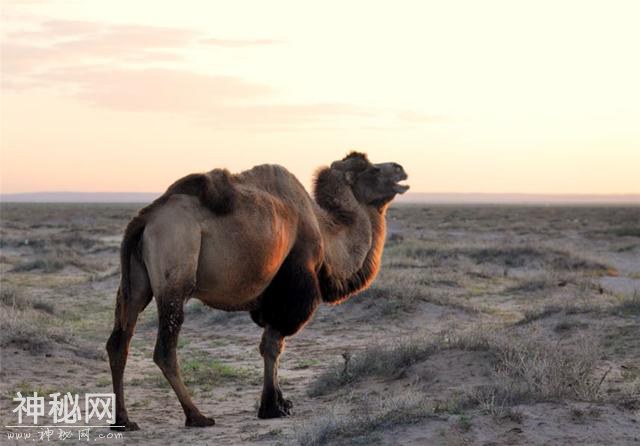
[106,152,409,430]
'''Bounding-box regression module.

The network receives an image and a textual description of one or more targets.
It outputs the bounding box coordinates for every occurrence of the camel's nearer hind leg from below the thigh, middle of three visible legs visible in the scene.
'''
[153,293,215,427]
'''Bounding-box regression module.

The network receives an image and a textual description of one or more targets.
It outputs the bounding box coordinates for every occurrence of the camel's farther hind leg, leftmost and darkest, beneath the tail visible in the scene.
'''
[107,262,152,431]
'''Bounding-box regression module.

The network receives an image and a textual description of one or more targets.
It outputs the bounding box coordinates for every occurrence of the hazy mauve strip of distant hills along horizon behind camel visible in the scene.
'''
[0,192,640,205]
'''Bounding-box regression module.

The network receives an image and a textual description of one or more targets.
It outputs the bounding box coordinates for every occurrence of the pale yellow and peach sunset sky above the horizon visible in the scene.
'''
[0,0,640,194]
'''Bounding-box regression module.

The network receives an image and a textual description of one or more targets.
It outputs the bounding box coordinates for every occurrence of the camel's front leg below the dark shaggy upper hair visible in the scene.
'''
[258,325,293,418]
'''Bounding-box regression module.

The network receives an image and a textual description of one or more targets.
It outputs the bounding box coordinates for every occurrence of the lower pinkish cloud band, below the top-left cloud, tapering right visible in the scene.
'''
[26,66,372,129]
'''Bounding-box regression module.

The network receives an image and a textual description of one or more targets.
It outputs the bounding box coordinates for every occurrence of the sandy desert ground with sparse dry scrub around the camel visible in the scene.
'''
[0,203,640,446]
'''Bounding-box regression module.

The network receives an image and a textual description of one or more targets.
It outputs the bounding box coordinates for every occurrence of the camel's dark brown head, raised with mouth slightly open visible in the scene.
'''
[331,152,409,206]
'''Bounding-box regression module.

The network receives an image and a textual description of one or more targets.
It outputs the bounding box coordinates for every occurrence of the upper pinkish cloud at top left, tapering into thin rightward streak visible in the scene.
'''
[0,20,277,81]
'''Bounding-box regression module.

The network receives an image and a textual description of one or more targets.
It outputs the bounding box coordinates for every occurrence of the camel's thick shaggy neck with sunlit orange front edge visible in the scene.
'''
[315,169,386,303]
